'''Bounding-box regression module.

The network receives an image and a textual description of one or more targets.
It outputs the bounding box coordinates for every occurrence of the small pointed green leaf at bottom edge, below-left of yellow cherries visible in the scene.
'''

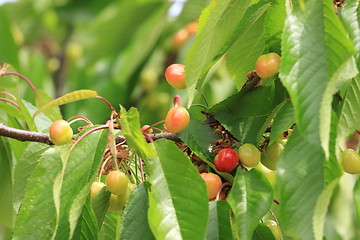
[72,197,98,240]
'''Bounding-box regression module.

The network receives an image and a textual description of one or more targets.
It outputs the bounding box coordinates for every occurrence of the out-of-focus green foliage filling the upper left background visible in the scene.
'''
[0,0,236,124]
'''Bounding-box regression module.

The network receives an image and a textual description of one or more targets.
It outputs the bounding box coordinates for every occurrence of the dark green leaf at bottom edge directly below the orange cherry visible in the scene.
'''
[206,201,233,240]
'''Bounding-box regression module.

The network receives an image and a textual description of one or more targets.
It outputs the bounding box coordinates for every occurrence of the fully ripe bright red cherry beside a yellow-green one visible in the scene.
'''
[214,148,239,172]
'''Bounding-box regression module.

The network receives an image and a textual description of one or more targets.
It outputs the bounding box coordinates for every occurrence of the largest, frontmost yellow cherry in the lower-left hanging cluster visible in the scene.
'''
[106,170,128,195]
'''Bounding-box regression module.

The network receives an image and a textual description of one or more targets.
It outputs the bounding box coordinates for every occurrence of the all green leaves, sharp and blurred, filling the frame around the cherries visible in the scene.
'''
[0,0,360,240]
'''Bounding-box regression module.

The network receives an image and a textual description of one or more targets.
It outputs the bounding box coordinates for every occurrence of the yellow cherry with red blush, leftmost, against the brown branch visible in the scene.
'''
[49,120,73,145]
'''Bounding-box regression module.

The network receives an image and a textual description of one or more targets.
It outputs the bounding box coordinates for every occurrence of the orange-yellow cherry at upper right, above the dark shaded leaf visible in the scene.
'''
[255,53,280,78]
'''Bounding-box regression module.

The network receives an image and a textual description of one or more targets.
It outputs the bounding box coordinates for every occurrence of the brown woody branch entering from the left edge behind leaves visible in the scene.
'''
[0,123,181,145]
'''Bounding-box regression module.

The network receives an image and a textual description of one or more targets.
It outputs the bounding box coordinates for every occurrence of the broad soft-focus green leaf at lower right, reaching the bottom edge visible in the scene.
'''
[277,128,325,240]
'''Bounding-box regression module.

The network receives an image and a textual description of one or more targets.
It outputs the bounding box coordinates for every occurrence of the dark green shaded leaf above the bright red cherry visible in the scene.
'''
[209,84,285,145]
